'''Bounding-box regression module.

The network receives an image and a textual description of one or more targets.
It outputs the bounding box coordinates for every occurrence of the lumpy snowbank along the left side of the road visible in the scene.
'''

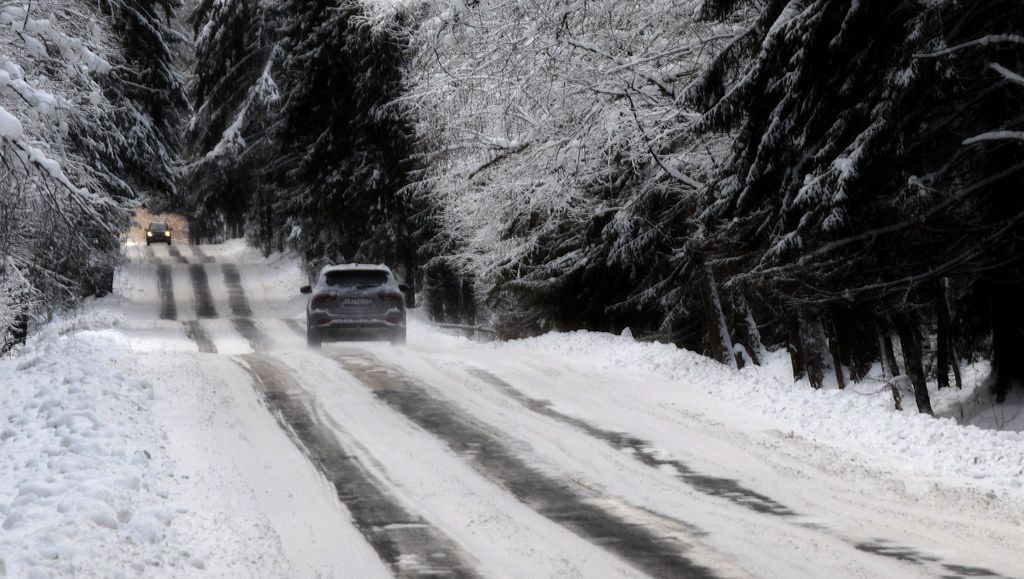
[0,322,193,577]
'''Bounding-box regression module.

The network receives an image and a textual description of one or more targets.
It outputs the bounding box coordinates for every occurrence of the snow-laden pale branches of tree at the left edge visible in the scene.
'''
[0,0,180,349]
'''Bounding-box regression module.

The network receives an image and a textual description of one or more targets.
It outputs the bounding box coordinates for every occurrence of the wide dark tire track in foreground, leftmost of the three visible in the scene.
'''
[242,355,477,577]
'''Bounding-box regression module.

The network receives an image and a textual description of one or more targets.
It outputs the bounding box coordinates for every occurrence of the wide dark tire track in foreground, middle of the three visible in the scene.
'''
[332,355,715,577]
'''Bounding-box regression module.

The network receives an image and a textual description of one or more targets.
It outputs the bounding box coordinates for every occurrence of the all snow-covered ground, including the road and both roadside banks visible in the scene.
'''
[0,237,1024,577]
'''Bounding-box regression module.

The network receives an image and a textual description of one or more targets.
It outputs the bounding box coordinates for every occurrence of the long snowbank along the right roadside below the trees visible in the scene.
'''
[438,330,1024,492]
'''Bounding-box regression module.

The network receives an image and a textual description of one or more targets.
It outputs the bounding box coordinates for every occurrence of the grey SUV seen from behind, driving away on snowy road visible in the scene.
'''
[300,264,409,347]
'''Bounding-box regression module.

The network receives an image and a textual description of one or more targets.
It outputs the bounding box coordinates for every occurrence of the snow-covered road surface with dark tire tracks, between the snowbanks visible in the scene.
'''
[74,241,1024,577]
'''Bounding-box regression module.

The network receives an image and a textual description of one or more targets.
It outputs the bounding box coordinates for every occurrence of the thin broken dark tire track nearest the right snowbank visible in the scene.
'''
[469,368,797,516]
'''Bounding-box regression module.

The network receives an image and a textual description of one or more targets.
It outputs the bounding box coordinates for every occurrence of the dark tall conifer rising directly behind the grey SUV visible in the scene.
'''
[276,0,425,270]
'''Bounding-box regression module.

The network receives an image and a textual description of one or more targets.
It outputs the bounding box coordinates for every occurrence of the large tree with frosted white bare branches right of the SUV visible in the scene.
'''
[407,0,743,338]
